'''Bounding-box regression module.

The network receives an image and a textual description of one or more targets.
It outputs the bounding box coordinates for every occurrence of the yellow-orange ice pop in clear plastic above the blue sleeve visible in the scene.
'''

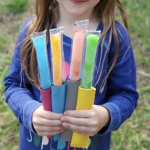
[51,34,62,86]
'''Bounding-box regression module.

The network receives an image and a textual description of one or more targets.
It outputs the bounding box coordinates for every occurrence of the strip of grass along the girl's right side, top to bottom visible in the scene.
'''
[111,0,150,150]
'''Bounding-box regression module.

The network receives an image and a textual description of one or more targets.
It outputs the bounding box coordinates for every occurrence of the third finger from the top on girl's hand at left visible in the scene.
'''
[34,126,64,132]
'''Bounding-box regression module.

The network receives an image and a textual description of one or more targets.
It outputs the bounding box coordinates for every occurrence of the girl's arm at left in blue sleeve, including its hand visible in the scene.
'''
[4,19,64,136]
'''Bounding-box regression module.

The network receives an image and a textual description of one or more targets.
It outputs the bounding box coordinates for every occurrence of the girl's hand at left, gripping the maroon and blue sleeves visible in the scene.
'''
[32,105,64,136]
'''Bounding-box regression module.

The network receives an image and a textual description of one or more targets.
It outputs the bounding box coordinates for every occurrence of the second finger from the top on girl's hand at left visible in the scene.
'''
[33,118,62,127]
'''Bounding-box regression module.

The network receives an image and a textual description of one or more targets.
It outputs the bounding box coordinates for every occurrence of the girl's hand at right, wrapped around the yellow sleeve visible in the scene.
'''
[61,105,110,136]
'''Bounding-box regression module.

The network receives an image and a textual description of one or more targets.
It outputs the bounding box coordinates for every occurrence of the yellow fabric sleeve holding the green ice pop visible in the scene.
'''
[71,87,96,148]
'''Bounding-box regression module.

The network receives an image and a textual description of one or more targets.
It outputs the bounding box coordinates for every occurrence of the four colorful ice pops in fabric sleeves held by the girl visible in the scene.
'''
[31,20,101,148]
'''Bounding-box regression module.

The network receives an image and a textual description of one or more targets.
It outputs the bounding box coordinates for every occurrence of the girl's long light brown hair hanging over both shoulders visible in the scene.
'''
[20,0,128,92]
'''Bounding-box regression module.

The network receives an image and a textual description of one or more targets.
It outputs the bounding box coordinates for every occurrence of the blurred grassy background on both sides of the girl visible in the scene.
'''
[0,0,150,150]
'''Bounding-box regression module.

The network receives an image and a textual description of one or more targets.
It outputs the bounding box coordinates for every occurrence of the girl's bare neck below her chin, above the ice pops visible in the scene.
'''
[55,5,100,38]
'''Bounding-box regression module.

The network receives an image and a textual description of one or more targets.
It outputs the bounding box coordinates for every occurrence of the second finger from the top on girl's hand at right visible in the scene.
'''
[61,116,90,126]
